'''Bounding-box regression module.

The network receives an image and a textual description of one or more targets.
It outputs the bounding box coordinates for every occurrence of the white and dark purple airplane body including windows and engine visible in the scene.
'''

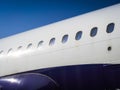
[0,4,120,90]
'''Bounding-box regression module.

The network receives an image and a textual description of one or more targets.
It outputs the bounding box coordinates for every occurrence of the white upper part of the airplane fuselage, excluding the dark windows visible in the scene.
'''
[0,4,120,76]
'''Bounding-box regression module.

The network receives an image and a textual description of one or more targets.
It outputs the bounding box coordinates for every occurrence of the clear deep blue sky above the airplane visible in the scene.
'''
[0,0,120,38]
